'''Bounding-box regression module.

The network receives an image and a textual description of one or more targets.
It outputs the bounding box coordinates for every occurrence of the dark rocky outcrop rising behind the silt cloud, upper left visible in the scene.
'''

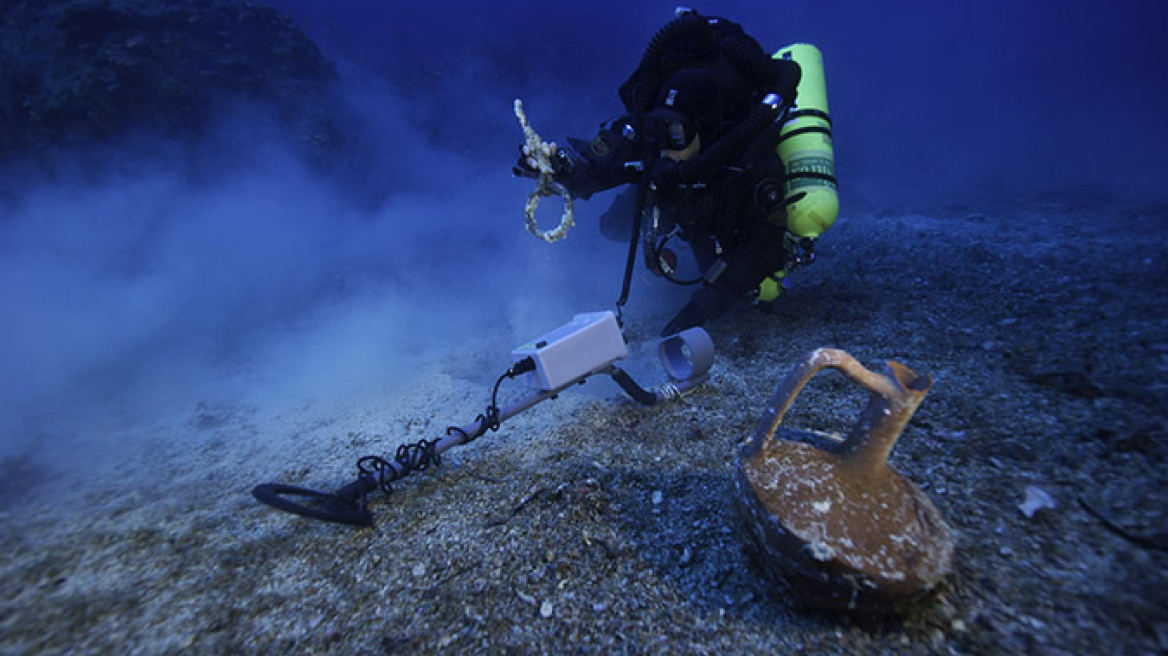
[0,0,335,159]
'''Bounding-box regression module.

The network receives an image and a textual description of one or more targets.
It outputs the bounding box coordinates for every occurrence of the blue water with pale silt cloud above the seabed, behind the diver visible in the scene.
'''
[0,0,1168,469]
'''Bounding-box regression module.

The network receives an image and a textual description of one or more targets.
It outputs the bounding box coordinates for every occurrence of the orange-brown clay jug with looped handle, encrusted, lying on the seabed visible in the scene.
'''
[736,349,953,610]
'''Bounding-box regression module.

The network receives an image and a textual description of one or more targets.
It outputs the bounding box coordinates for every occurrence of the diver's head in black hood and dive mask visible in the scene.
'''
[645,68,718,151]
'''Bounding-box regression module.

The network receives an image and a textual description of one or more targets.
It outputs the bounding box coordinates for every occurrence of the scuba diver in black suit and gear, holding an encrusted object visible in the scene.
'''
[513,9,835,336]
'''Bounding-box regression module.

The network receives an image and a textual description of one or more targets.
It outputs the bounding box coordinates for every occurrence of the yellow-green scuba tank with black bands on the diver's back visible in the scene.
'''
[758,43,840,302]
